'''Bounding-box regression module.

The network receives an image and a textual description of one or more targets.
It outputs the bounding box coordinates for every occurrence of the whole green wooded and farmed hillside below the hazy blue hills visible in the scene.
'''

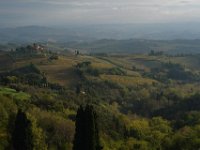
[0,44,200,150]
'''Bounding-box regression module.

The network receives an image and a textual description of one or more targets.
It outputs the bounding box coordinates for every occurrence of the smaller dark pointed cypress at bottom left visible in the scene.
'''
[12,109,33,150]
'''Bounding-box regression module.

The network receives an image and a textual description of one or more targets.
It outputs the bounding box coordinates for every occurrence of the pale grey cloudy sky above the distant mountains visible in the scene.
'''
[0,0,200,27]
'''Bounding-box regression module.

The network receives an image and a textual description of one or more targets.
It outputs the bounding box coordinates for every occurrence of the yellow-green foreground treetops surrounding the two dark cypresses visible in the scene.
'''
[0,82,200,150]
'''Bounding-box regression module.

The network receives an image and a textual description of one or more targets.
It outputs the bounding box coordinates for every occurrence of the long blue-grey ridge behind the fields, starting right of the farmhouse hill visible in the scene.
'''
[63,39,200,54]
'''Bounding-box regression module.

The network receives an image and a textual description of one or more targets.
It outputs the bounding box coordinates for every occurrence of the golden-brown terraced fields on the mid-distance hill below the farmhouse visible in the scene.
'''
[0,54,200,89]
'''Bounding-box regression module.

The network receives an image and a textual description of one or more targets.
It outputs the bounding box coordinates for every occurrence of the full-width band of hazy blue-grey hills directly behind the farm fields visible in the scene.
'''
[0,38,200,55]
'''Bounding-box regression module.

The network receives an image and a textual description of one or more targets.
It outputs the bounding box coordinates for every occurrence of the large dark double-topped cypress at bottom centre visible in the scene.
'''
[73,105,102,150]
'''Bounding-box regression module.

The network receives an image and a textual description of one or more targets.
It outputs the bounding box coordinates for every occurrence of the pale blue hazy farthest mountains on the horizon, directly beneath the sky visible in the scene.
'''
[0,23,200,43]
